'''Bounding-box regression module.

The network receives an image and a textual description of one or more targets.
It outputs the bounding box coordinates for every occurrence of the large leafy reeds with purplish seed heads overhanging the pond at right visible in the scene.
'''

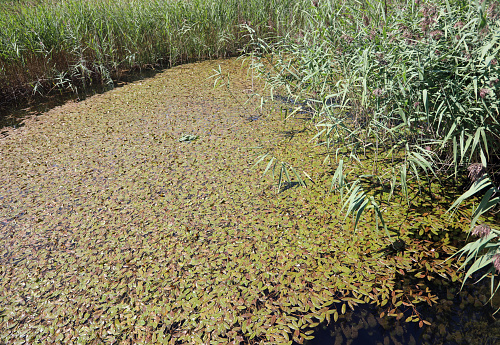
[249,0,500,306]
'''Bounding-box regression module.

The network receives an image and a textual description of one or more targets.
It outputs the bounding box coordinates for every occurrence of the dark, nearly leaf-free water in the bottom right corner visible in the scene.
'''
[294,280,500,345]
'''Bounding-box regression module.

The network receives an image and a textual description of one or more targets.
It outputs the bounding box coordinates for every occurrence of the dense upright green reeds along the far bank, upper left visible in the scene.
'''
[0,0,304,105]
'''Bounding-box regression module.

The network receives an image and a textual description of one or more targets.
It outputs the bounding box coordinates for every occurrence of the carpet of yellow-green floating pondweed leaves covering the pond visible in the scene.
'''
[0,60,500,345]
